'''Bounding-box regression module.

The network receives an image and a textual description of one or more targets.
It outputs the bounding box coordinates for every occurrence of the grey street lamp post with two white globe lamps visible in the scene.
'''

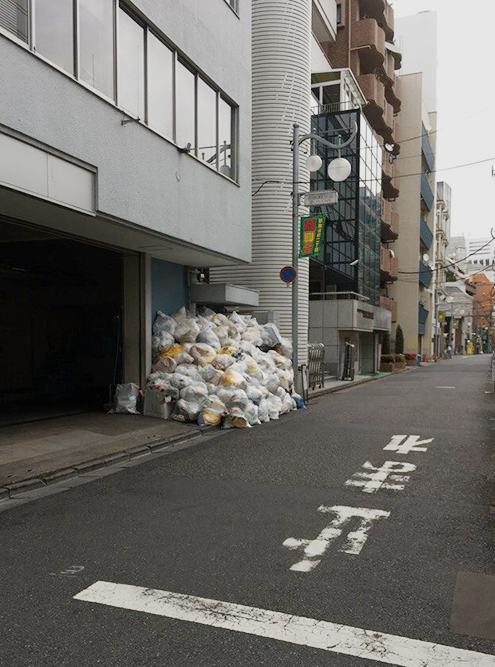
[292,123,358,392]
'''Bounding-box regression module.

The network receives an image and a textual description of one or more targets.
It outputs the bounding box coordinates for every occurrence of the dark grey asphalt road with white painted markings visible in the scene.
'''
[0,355,495,667]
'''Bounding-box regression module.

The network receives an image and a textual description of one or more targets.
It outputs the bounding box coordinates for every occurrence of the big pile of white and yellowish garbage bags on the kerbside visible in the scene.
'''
[146,308,302,428]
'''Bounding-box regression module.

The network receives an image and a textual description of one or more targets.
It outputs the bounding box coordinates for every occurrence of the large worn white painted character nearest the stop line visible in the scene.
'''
[283,505,390,572]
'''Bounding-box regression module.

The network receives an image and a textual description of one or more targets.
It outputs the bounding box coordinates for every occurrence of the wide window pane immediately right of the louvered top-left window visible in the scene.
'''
[34,0,74,74]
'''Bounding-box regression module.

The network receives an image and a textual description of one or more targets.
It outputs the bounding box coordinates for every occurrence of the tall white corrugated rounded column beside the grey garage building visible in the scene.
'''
[211,0,311,363]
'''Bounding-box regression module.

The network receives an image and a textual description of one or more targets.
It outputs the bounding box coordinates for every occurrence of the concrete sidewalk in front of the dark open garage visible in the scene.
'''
[0,412,207,497]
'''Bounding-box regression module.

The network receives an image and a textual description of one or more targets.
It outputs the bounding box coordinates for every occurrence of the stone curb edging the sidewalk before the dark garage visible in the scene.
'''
[0,426,219,501]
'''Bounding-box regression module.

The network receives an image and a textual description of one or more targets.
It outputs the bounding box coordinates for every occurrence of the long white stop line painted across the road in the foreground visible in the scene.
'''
[74,581,495,667]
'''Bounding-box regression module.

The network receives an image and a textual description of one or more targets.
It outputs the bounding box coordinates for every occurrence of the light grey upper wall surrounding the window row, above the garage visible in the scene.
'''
[0,0,251,261]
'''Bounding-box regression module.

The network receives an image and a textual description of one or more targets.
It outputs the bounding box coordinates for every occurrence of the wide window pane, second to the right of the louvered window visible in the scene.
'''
[79,0,115,99]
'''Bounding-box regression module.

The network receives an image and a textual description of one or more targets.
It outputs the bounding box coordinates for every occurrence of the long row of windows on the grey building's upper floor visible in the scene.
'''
[0,0,237,179]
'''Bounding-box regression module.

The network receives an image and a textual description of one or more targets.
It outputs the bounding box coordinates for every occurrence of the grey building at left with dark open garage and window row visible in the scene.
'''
[0,0,252,420]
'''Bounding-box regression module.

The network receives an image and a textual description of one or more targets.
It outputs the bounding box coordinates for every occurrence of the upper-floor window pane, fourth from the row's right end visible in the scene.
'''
[148,32,174,139]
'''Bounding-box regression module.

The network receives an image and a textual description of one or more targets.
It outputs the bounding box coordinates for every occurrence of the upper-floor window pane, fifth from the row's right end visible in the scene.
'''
[118,9,145,120]
